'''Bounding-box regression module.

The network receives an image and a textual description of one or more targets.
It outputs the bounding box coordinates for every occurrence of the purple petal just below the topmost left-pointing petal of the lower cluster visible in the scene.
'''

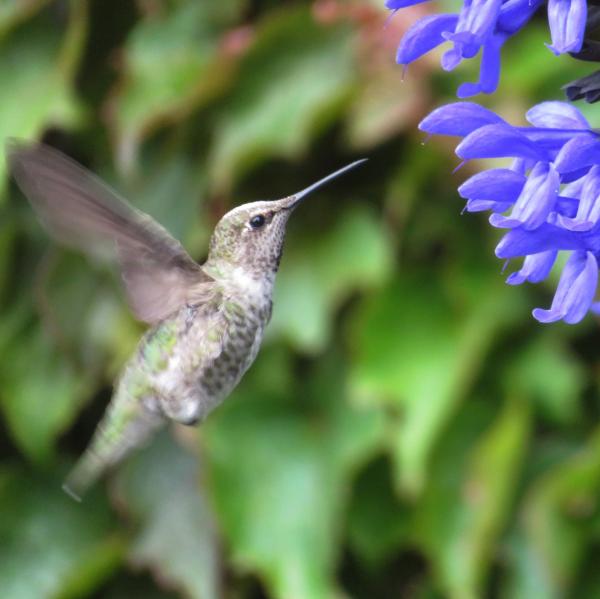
[456,123,549,161]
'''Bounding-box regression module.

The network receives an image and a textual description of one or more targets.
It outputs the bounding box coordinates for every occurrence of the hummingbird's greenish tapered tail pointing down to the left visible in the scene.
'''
[62,396,166,501]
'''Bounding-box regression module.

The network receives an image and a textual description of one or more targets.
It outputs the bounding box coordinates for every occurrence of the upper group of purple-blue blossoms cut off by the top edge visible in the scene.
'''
[385,0,587,98]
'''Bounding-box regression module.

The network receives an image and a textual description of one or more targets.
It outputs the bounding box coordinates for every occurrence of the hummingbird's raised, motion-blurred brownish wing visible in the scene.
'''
[7,142,212,324]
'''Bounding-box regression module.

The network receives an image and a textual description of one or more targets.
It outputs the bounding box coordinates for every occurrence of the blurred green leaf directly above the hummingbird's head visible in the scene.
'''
[210,7,354,192]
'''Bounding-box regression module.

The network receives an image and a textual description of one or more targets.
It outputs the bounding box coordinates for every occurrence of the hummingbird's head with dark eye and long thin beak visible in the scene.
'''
[208,160,364,278]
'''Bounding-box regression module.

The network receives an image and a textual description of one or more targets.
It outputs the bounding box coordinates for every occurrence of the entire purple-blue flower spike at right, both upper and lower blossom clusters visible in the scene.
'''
[385,0,600,323]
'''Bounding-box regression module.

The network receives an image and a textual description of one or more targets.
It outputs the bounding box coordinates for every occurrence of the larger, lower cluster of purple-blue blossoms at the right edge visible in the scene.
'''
[419,102,600,323]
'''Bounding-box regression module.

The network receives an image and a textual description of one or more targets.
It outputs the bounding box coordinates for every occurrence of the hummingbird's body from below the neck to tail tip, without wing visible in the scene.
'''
[67,274,272,497]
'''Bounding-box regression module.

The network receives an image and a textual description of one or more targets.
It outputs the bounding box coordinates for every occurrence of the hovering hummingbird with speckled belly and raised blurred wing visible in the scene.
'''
[7,141,365,501]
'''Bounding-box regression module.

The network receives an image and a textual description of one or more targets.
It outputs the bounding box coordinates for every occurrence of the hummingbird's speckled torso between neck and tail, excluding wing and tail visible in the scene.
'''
[131,266,272,424]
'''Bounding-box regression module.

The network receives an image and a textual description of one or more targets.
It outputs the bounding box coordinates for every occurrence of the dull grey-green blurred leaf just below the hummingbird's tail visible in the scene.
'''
[117,432,220,599]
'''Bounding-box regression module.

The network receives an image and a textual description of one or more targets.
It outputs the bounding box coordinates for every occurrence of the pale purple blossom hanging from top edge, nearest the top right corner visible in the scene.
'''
[548,0,587,54]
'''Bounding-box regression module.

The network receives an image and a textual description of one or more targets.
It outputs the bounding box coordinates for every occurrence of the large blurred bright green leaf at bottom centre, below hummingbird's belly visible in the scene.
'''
[202,354,382,599]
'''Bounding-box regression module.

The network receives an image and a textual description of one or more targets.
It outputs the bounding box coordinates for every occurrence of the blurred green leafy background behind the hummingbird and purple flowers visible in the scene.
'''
[0,0,600,599]
